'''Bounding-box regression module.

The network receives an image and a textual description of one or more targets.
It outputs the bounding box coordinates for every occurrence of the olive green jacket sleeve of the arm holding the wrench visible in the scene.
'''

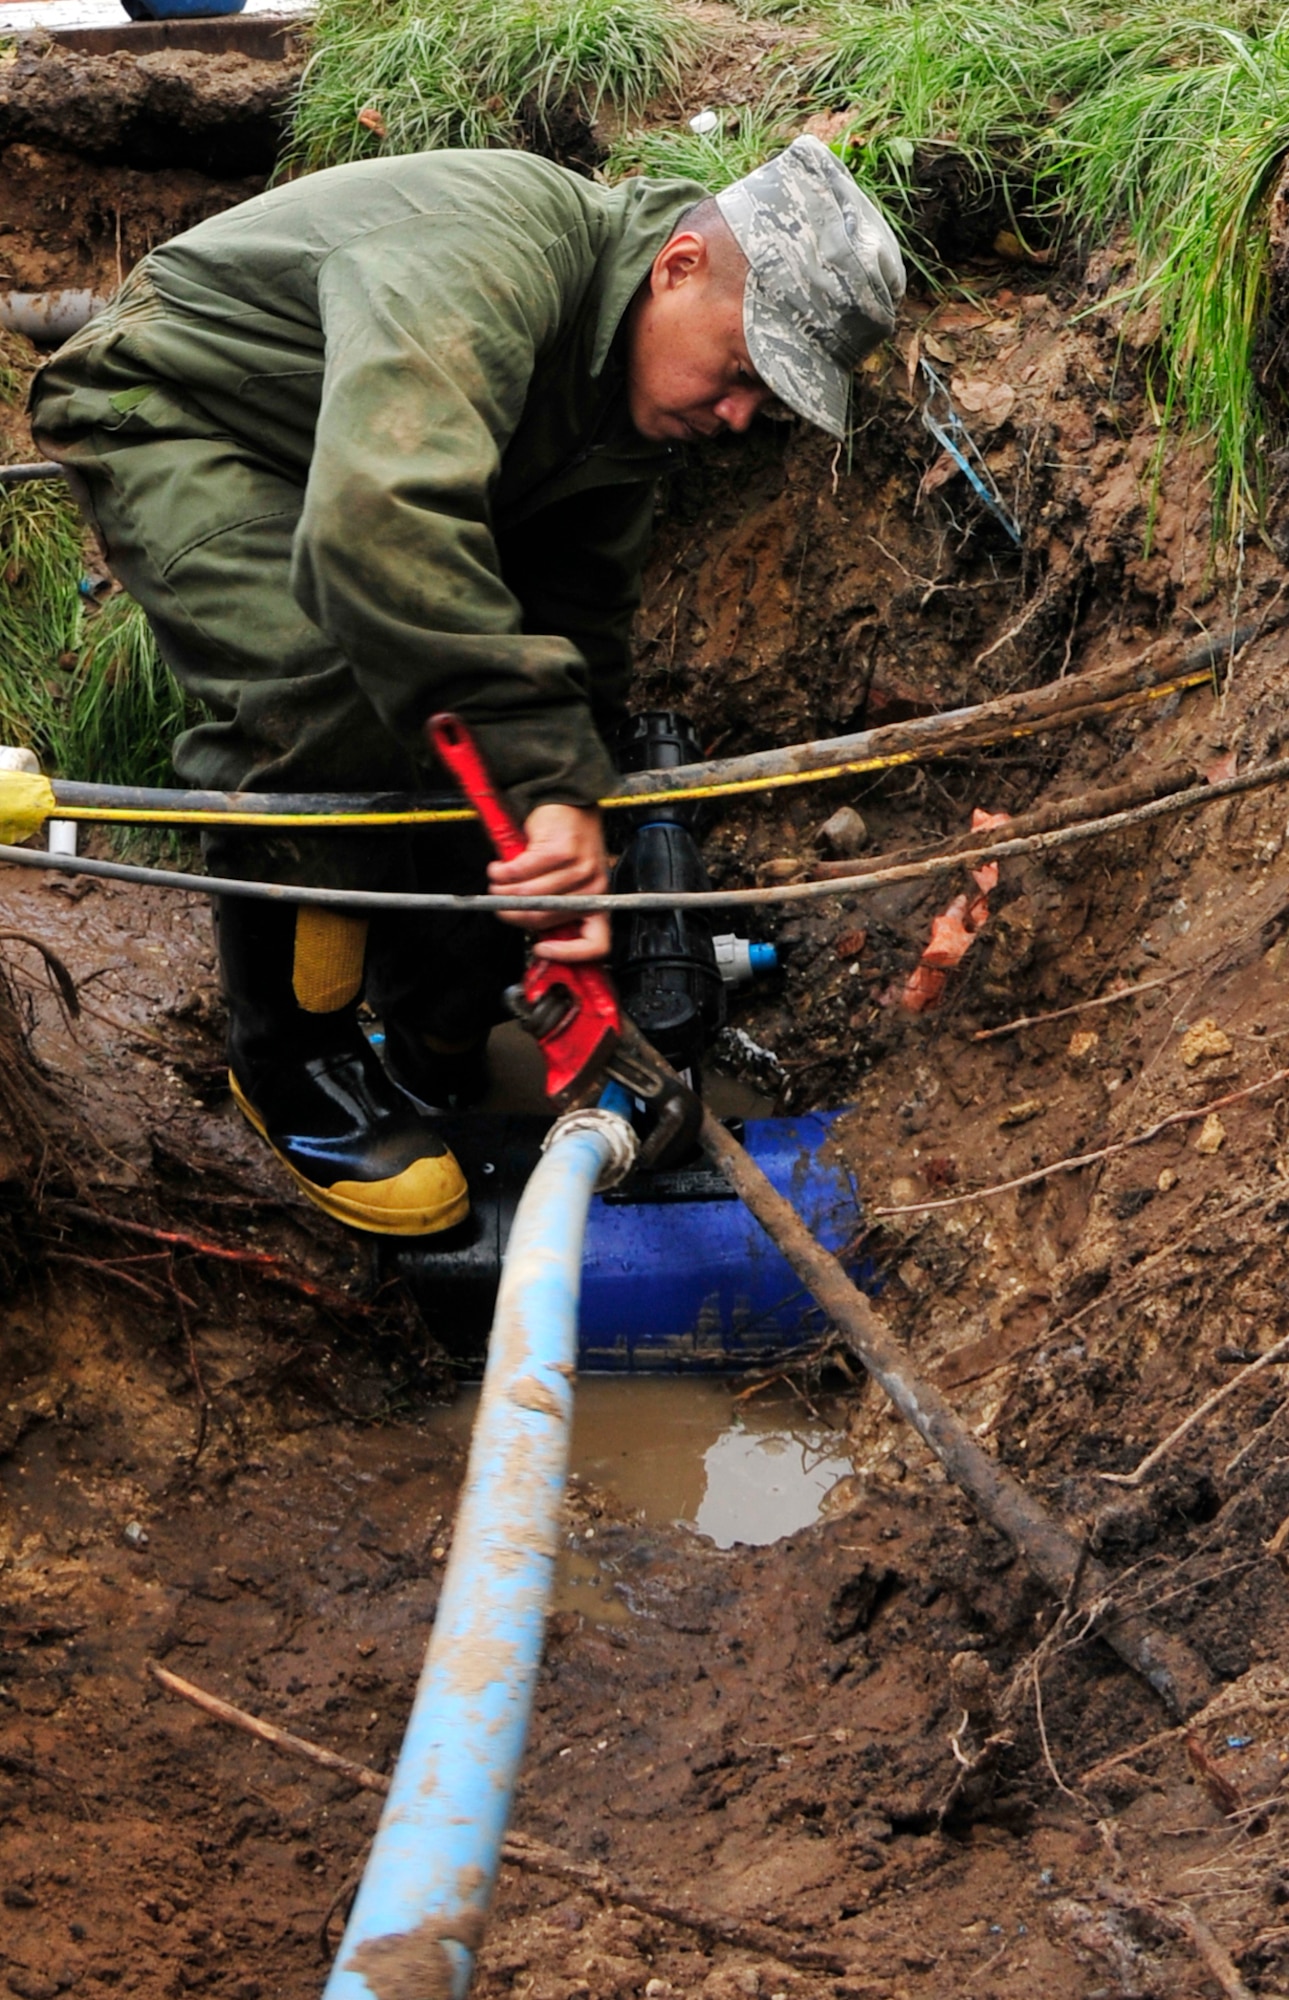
[292,214,612,816]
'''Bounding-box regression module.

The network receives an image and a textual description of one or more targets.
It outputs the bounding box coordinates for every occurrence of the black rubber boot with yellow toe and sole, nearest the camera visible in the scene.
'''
[218,896,470,1236]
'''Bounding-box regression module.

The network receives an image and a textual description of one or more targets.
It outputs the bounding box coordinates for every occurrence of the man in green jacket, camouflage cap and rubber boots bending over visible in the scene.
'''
[32,138,905,1234]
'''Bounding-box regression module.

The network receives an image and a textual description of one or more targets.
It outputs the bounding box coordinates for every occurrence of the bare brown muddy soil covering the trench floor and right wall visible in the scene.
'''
[0,27,1289,2000]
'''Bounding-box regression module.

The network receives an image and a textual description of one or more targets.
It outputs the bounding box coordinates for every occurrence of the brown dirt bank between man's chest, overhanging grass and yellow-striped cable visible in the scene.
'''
[638,284,1219,750]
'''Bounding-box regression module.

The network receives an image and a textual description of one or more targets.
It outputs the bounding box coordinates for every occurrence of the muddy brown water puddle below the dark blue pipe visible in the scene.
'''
[432,1376,853,1622]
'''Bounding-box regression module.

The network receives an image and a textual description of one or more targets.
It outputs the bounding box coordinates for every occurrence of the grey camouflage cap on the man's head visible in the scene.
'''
[717,136,905,438]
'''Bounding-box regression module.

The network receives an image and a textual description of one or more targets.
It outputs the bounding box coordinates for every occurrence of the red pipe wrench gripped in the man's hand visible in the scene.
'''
[426,714,703,1168]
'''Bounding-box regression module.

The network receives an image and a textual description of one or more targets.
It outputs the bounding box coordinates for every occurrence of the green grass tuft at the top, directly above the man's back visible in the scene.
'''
[286,0,701,170]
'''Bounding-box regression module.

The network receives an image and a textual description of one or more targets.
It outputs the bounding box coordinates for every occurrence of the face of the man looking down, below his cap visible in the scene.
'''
[626,232,771,440]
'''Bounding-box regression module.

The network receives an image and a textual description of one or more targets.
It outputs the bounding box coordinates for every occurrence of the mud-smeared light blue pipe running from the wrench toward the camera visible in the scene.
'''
[324,1084,636,2000]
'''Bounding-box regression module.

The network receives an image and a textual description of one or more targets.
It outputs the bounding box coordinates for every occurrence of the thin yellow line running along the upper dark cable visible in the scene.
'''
[32,666,1213,830]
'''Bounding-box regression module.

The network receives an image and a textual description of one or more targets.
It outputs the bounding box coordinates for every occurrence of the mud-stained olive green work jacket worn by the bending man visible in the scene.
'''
[34,152,705,814]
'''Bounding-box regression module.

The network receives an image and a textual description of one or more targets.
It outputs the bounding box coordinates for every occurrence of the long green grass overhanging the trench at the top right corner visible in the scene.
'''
[809,0,1289,536]
